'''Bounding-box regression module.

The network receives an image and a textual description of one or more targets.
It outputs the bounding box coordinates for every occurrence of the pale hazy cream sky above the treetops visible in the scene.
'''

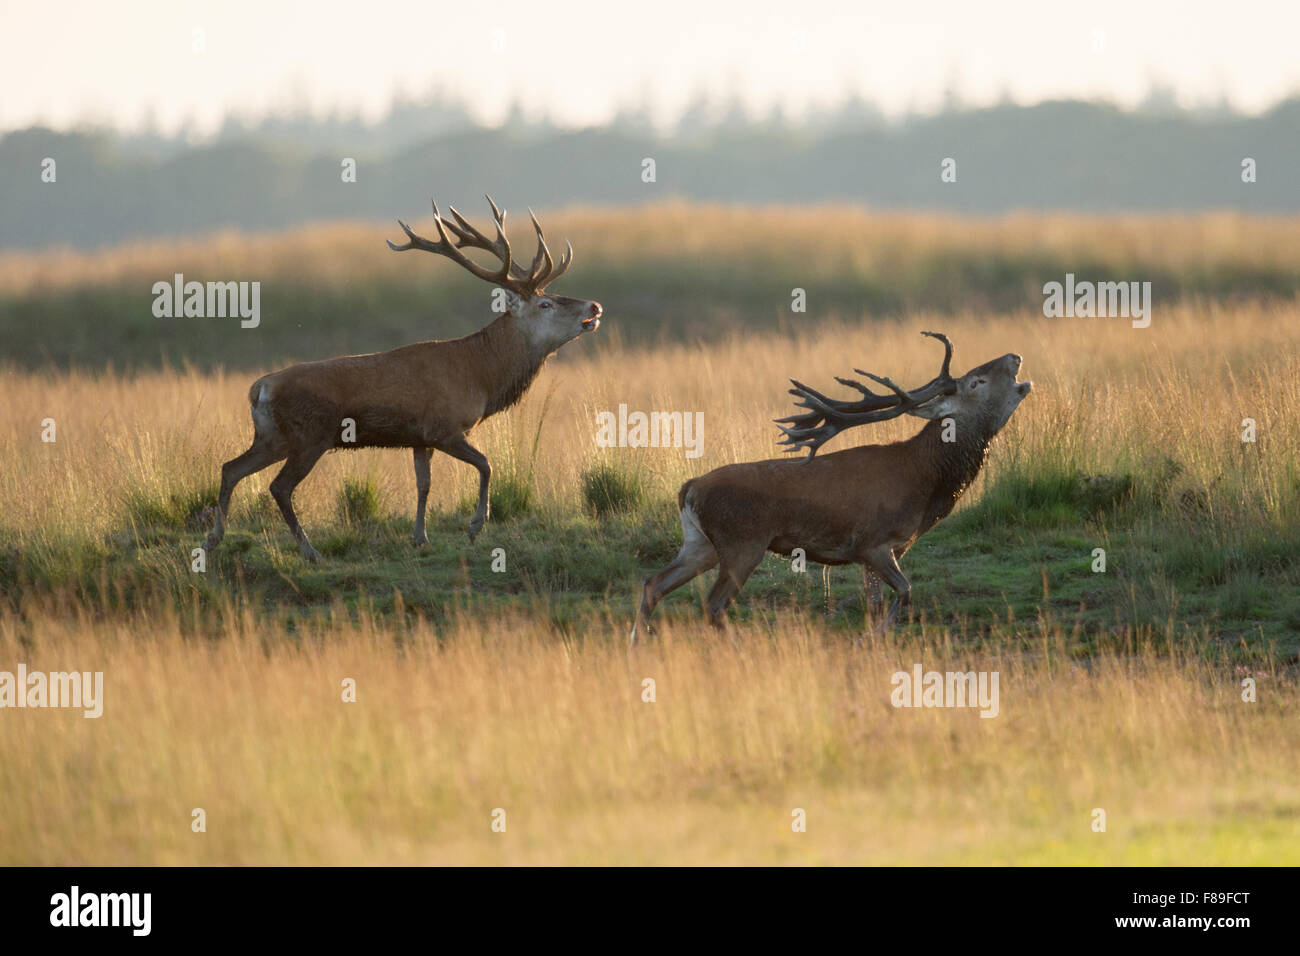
[0,0,1300,130]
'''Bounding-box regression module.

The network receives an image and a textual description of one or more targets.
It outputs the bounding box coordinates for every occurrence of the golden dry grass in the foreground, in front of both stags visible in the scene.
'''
[0,613,1300,865]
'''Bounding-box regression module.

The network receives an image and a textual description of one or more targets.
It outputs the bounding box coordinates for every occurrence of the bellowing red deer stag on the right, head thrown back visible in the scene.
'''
[632,332,1032,645]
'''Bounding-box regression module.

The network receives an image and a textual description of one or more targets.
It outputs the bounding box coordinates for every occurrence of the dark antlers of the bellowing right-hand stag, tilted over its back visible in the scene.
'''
[774,332,957,460]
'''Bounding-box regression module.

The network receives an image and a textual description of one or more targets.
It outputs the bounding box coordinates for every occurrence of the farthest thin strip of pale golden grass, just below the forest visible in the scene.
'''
[0,208,1300,294]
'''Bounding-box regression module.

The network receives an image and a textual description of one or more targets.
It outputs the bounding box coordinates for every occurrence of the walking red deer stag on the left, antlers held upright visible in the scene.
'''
[207,196,601,561]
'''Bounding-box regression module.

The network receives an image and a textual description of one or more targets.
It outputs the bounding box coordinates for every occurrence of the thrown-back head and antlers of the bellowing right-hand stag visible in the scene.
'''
[776,332,1034,458]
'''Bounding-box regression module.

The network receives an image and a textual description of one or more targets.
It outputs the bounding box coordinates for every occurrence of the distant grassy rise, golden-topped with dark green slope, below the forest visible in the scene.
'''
[0,204,1300,372]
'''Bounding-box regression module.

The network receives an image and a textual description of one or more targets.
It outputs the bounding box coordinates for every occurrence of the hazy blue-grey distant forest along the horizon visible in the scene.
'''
[0,90,1300,248]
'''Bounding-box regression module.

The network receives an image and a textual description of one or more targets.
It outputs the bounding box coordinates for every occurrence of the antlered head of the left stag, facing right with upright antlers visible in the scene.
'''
[389,196,602,352]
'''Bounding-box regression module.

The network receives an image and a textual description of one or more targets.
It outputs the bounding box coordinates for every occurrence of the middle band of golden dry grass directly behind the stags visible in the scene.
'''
[0,304,1300,548]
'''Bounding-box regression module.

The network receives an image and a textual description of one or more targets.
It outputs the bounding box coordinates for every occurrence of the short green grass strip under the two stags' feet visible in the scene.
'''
[0,473,1300,657]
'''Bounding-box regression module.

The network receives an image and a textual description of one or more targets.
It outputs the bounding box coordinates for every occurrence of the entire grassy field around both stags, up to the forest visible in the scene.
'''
[0,207,1300,864]
